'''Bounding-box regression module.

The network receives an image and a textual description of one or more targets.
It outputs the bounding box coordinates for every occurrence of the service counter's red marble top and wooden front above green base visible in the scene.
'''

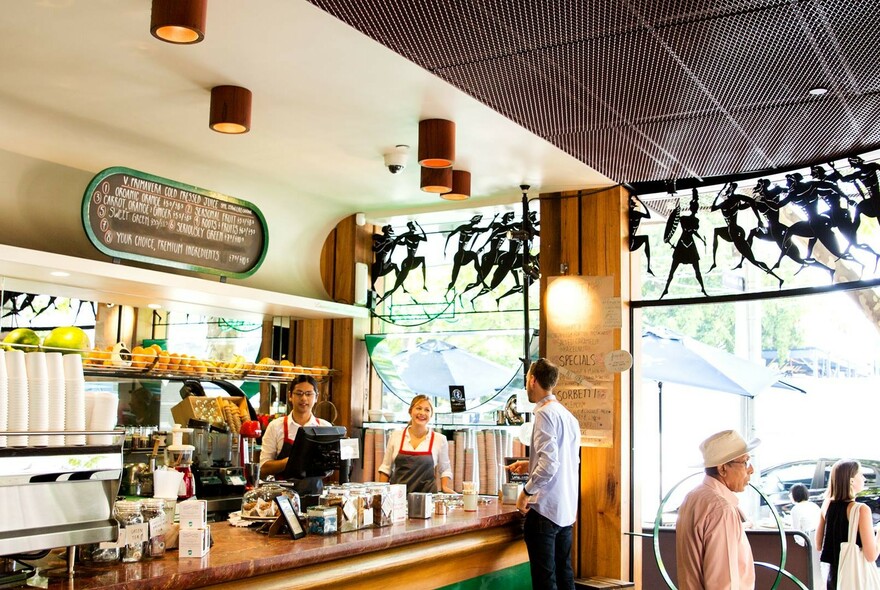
[24,499,528,590]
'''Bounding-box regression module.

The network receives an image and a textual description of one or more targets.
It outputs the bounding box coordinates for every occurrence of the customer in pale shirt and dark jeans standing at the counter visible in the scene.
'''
[507,358,581,590]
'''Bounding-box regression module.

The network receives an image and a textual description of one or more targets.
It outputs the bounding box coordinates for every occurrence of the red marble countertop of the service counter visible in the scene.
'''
[38,500,522,590]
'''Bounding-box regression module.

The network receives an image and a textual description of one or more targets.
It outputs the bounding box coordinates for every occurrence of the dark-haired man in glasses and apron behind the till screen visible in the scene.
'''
[260,375,331,477]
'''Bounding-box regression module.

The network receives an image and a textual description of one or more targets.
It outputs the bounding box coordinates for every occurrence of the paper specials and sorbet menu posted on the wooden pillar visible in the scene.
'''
[547,276,620,447]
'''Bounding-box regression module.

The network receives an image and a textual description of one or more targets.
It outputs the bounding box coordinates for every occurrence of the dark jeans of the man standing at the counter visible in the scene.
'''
[523,509,574,590]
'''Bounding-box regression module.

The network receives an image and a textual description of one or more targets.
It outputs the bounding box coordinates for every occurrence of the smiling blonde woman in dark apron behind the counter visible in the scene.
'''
[379,395,453,494]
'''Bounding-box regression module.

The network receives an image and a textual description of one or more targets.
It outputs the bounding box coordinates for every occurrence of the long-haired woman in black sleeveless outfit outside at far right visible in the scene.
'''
[816,459,880,590]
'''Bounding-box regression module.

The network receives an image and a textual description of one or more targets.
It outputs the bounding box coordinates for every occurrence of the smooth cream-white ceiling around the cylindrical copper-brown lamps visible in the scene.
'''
[0,0,611,297]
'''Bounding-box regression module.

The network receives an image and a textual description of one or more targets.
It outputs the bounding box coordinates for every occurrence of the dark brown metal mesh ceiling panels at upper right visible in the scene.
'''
[311,0,880,187]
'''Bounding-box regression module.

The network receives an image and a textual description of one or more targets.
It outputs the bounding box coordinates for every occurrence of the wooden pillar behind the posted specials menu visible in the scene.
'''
[541,188,631,579]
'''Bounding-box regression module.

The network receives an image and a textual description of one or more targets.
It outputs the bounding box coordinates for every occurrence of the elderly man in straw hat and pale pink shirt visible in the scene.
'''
[675,430,761,590]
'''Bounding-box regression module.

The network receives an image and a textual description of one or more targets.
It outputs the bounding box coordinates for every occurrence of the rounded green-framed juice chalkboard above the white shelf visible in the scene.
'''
[82,167,269,278]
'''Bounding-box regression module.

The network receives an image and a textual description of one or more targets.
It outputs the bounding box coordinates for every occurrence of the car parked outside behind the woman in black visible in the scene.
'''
[758,459,880,524]
